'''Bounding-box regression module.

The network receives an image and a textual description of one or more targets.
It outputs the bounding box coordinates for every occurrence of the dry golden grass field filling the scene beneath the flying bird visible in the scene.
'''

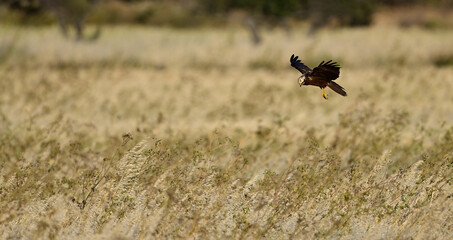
[0,26,453,239]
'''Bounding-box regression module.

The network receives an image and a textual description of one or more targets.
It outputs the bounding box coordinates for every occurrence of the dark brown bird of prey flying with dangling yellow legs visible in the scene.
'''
[289,54,347,99]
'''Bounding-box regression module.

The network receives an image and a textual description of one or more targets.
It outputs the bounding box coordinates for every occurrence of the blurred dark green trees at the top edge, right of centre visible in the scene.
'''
[199,0,377,43]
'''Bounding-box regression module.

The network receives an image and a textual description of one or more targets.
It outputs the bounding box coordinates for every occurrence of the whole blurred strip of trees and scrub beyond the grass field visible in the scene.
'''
[0,0,453,39]
